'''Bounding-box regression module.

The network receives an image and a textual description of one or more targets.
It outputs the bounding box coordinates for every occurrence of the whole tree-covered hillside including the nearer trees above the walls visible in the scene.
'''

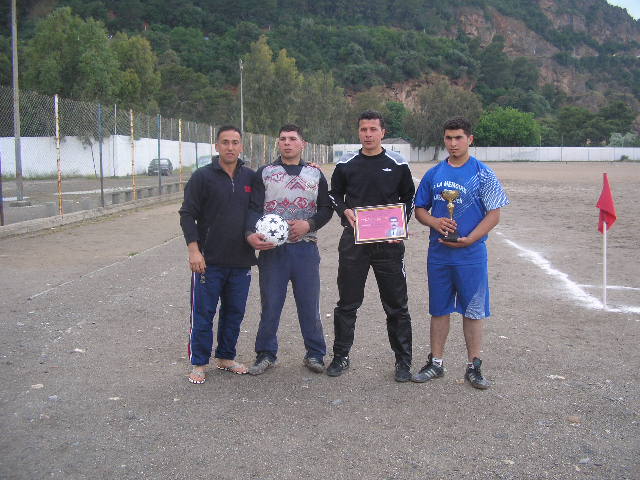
[0,0,640,145]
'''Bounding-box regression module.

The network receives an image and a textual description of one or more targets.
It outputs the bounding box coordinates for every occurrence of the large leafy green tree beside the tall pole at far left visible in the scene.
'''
[23,8,120,103]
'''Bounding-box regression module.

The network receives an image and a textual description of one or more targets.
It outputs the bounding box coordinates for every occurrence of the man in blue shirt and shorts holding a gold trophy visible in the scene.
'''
[411,117,509,389]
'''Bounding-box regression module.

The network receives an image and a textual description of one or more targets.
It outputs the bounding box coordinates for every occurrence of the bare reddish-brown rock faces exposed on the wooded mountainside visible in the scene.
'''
[382,0,640,110]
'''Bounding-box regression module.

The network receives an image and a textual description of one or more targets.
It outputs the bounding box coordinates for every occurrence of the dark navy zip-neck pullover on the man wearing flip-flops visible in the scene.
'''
[179,156,256,267]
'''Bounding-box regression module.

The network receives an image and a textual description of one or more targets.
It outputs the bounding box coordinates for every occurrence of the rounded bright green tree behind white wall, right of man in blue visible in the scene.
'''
[474,107,541,147]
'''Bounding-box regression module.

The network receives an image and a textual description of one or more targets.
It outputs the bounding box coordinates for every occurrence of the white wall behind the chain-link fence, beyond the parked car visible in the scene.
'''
[0,135,216,177]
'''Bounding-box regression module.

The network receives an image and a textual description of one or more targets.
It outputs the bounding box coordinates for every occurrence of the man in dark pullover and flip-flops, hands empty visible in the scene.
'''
[180,126,256,384]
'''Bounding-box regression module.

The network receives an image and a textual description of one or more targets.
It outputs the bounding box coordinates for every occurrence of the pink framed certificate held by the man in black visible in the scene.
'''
[353,203,409,243]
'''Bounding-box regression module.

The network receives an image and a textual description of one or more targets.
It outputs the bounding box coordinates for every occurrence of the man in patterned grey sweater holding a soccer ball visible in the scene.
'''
[247,125,333,375]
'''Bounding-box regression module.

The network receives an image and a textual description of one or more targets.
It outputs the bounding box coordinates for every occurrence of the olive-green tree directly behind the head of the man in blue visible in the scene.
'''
[404,80,482,160]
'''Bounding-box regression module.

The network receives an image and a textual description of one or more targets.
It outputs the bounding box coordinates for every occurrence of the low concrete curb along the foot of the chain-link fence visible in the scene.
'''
[0,192,183,239]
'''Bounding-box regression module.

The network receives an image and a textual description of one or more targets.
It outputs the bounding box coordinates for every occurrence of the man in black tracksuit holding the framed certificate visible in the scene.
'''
[327,111,415,382]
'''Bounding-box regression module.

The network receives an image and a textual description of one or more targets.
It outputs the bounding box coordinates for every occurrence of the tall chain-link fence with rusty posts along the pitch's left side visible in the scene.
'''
[0,87,331,225]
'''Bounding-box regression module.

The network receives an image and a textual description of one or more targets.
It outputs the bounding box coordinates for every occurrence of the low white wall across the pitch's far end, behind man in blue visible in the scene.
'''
[411,147,640,162]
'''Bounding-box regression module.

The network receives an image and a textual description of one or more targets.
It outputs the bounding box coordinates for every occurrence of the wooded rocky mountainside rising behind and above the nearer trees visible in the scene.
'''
[0,0,640,113]
